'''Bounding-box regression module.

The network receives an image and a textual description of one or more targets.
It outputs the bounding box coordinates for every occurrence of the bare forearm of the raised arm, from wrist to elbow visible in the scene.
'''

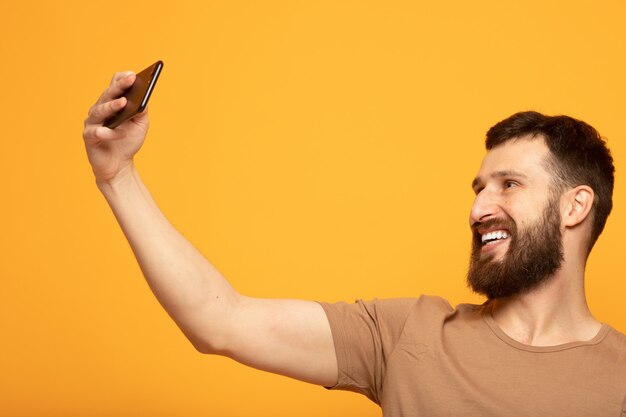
[98,165,239,351]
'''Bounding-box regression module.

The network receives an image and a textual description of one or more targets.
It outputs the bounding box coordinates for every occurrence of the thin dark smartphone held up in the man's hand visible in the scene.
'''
[104,61,163,129]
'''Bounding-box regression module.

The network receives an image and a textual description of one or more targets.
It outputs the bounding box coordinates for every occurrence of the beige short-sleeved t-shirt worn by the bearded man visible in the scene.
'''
[321,296,626,417]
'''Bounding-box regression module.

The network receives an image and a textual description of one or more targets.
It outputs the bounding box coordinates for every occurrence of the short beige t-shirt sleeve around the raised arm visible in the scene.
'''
[320,298,418,404]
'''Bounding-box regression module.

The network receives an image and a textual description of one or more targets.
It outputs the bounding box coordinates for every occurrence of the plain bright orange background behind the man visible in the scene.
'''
[0,0,626,417]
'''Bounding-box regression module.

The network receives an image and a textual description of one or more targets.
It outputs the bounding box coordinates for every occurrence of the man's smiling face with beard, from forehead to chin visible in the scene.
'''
[468,138,563,299]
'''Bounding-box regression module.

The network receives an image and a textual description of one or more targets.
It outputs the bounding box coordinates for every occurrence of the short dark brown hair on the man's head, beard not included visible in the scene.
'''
[485,111,615,250]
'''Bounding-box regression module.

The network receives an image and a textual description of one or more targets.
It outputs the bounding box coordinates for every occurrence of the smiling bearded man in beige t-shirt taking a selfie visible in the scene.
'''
[83,73,626,416]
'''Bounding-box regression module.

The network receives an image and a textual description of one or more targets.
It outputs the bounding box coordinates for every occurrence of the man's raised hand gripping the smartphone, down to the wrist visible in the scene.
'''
[83,72,148,183]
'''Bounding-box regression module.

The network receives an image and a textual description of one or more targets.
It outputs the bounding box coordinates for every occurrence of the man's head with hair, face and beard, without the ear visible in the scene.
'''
[468,112,614,298]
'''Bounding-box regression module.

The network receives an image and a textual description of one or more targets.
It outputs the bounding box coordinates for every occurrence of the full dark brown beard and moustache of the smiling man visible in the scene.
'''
[467,196,563,300]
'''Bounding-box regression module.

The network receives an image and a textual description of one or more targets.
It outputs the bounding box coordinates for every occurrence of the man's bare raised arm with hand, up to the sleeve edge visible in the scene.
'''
[83,73,337,386]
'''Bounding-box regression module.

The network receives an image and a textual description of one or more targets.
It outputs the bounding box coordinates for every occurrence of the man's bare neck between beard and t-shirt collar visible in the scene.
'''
[492,265,602,346]
